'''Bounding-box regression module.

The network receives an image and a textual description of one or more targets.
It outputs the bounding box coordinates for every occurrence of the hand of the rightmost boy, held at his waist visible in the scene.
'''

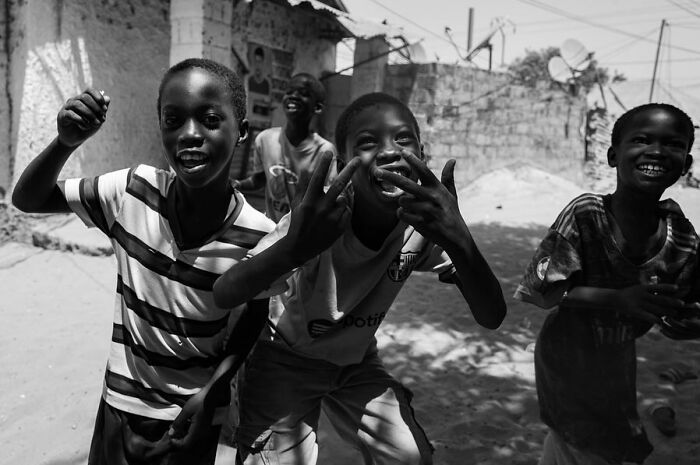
[617,284,686,323]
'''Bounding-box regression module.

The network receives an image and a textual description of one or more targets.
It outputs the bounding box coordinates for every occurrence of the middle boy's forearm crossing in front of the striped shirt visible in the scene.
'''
[214,236,303,308]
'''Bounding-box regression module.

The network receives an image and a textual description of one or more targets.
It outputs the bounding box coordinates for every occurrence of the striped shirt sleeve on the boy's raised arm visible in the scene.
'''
[62,169,132,236]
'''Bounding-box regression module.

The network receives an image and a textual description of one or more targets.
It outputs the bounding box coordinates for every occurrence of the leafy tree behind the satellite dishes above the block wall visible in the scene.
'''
[508,47,625,93]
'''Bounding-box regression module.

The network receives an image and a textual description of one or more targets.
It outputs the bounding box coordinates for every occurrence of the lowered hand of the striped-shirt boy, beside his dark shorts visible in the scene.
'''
[168,388,223,450]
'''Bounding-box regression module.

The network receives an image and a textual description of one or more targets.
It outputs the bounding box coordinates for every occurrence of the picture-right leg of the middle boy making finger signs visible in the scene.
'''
[323,353,432,465]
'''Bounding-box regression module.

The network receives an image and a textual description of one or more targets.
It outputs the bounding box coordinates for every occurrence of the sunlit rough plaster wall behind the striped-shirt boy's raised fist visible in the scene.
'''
[7,0,170,190]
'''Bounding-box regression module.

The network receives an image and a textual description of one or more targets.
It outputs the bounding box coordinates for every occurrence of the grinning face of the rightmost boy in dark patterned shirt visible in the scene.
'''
[608,108,692,194]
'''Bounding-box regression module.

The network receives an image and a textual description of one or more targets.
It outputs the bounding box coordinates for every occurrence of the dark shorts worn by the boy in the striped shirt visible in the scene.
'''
[88,399,221,465]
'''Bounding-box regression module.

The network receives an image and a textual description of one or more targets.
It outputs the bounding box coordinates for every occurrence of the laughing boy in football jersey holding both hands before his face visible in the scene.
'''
[214,93,506,465]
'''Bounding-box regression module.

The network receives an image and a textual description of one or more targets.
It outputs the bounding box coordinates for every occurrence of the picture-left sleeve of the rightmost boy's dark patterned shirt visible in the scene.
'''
[514,208,582,308]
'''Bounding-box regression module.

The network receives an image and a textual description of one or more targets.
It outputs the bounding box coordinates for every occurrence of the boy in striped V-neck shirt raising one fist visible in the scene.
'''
[13,59,274,465]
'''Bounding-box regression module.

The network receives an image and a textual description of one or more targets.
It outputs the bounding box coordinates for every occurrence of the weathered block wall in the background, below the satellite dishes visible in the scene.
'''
[384,63,586,188]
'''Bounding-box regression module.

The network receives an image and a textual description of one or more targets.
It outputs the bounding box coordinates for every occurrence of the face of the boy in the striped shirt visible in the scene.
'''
[160,68,247,188]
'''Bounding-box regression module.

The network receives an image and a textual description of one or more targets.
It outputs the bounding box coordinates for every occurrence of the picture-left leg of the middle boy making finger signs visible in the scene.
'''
[236,344,337,465]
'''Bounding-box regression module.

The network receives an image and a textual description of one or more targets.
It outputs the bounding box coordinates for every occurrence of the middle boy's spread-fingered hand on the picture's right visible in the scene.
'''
[377,151,469,250]
